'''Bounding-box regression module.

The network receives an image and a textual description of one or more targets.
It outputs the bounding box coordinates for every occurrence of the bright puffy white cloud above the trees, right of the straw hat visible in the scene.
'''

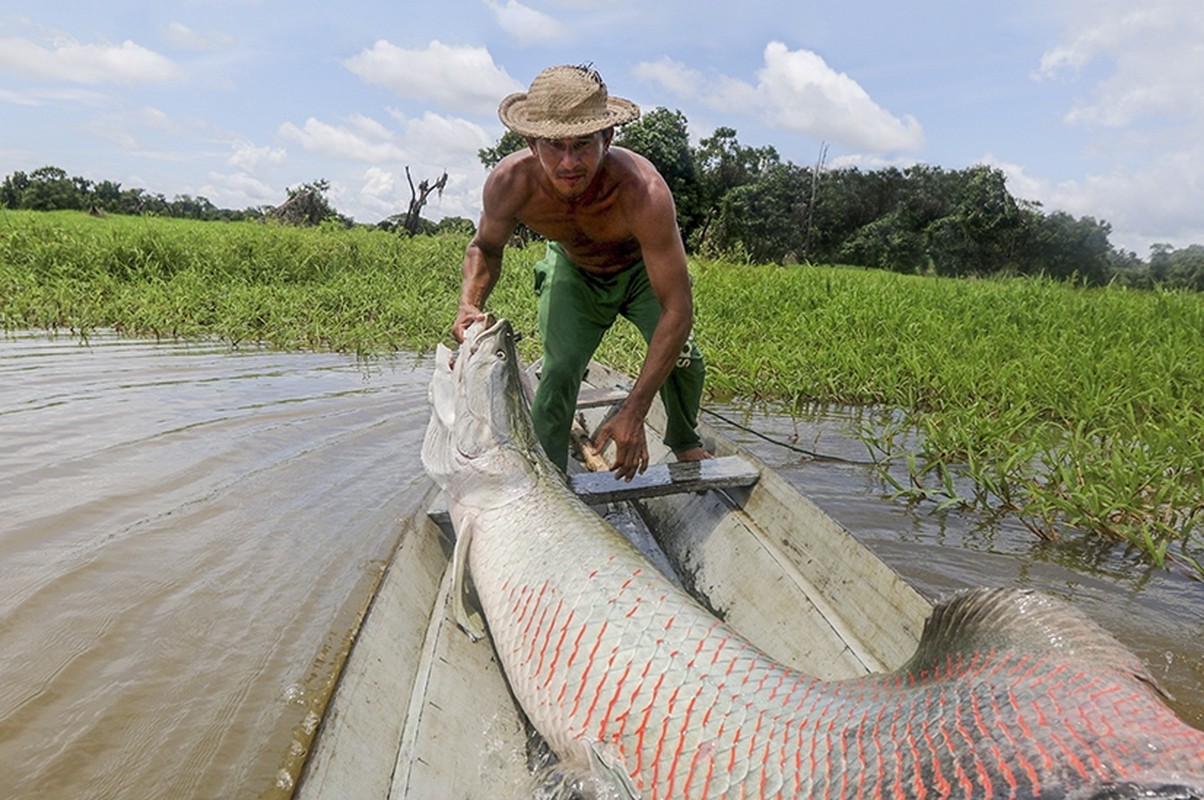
[635,42,923,153]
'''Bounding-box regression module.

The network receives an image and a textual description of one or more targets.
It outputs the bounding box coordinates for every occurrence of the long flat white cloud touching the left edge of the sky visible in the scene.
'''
[0,39,179,84]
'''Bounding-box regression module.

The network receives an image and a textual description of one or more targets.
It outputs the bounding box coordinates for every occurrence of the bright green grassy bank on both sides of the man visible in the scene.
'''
[0,212,1204,576]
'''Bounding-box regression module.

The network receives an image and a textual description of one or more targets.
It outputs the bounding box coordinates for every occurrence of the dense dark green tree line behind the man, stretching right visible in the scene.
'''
[479,108,1204,290]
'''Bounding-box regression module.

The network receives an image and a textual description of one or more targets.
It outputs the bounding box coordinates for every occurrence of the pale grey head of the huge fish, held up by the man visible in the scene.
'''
[423,314,547,489]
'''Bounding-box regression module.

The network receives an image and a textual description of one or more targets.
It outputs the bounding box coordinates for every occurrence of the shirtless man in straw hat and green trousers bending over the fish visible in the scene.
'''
[452,66,710,481]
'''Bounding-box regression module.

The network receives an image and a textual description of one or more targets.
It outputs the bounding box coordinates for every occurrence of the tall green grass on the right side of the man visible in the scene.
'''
[669,263,1204,575]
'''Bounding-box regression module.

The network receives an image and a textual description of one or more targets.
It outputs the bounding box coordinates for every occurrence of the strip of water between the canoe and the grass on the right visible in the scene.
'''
[708,407,1204,728]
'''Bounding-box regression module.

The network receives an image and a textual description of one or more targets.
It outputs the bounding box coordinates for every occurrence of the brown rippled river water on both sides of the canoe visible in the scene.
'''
[0,334,1204,799]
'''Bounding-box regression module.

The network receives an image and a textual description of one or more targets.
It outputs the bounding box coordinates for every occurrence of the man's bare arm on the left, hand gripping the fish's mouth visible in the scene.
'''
[452,159,518,342]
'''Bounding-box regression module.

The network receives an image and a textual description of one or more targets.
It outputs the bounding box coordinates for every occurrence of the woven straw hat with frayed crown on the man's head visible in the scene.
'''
[497,65,639,139]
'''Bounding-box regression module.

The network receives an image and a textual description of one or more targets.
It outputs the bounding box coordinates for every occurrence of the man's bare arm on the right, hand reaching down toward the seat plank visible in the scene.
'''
[597,159,694,481]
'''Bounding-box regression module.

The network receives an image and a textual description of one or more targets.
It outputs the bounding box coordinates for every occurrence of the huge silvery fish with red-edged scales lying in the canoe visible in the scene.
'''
[423,320,1204,800]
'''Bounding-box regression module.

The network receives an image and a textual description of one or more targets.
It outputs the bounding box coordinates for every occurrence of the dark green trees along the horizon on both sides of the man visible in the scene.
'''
[9,108,1204,290]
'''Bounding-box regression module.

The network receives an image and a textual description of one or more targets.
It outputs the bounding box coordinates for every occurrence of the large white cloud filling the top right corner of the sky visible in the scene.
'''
[1002,0,1204,250]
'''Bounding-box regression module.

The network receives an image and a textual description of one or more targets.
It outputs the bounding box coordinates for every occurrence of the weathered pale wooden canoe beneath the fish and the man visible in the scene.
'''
[295,364,931,800]
